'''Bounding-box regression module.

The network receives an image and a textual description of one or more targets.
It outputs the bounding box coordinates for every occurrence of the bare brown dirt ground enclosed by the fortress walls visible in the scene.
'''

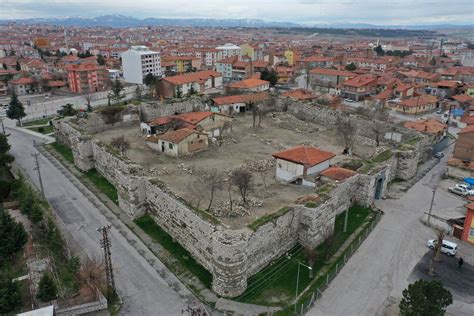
[95,113,362,228]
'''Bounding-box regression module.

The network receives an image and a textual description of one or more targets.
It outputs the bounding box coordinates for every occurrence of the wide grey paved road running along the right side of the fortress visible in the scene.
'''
[308,158,474,315]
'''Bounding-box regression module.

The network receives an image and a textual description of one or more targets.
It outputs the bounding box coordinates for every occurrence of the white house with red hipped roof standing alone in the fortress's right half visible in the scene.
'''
[272,146,336,186]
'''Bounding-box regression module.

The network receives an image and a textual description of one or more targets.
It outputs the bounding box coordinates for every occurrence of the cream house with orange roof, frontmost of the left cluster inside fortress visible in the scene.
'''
[146,128,208,157]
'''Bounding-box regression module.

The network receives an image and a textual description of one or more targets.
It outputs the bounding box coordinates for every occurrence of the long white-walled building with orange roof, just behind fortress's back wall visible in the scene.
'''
[160,70,222,98]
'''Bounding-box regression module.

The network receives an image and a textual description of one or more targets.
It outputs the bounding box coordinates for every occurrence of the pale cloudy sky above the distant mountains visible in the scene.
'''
[0,0,474,25]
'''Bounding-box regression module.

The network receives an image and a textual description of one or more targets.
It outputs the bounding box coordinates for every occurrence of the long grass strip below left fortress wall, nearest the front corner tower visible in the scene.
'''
[134,214,212,288]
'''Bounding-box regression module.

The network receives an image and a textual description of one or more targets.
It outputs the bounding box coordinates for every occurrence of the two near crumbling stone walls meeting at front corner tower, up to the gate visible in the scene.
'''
[54,110,396,297]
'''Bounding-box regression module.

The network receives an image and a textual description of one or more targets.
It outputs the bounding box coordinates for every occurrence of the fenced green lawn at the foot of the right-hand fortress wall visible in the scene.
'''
[235,205,371,306]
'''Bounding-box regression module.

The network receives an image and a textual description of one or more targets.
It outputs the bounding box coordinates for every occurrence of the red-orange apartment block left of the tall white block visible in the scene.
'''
[65,63,110,93]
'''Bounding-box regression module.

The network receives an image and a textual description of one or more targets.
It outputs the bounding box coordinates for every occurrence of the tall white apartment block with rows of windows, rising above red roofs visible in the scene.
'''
[122,46,162,84]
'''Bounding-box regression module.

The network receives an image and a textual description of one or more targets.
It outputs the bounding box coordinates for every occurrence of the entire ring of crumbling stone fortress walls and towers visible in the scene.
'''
[53,99,431,297]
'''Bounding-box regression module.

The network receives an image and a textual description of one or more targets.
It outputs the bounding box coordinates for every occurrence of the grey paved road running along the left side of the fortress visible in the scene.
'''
[7,128,190,315]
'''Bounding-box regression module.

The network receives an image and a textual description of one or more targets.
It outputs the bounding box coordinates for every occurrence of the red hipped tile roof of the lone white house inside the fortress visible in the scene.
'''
[272,145,336,166]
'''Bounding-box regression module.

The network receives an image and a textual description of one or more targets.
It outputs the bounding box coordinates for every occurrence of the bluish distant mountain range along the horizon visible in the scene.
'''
[0,14,474,30]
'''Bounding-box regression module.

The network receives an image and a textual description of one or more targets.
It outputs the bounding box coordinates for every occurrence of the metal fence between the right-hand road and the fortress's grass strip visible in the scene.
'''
[288,210,382,315]
